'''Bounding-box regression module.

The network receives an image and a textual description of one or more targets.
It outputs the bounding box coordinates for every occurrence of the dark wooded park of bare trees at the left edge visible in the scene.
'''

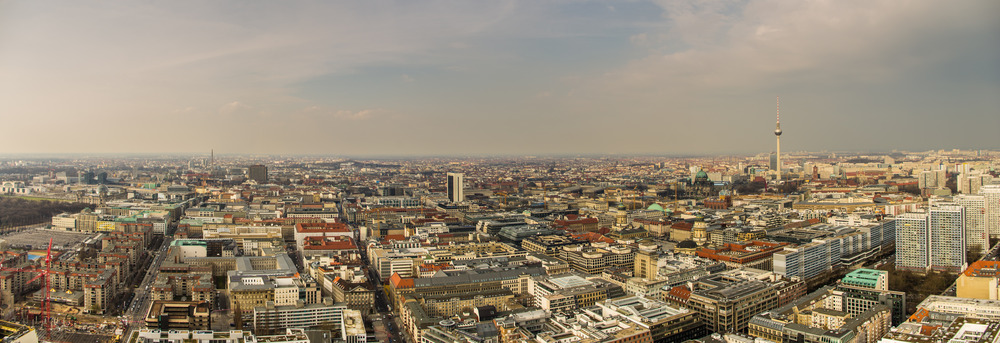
[0,197,90,229]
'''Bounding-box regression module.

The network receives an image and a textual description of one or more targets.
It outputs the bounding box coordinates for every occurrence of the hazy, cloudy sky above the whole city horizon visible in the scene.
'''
[0,0,1000,156]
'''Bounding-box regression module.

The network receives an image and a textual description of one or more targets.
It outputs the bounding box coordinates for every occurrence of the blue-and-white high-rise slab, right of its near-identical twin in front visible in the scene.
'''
[927,203,966,272]
